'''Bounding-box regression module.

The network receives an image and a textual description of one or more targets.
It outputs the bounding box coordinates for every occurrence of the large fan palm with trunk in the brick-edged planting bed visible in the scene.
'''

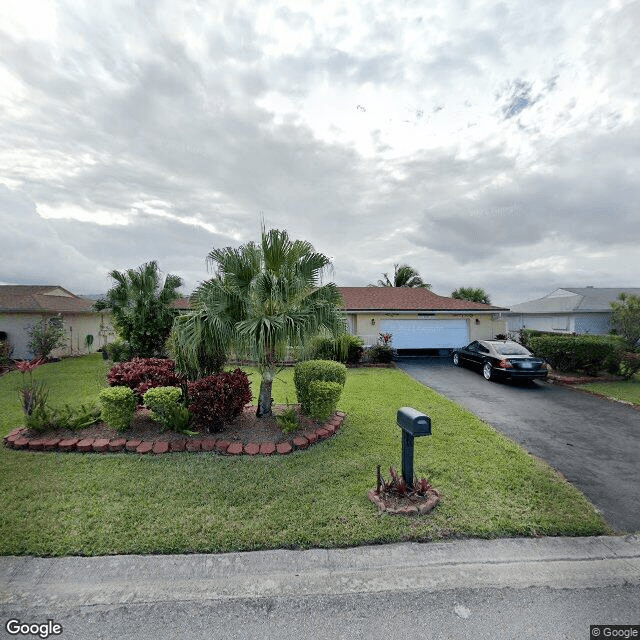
[173,227,346,417]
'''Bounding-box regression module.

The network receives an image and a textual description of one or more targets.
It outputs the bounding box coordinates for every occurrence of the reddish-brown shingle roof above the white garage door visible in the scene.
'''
[338,287,506,311]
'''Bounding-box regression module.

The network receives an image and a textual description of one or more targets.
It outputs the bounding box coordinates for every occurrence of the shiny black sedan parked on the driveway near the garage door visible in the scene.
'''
[453,340,549,380]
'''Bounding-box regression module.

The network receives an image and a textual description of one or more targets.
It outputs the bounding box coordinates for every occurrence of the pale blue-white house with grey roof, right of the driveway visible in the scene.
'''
[504,287,640,335]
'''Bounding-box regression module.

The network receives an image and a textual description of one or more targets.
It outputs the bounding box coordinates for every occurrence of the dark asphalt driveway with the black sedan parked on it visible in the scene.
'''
[397,358,640,532]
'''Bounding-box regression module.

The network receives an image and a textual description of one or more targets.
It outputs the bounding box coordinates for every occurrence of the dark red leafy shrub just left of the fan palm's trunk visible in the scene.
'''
[188,369,252,432]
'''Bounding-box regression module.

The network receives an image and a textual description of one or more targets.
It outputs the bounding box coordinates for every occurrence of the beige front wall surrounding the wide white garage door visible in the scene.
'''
[347,313,507,345]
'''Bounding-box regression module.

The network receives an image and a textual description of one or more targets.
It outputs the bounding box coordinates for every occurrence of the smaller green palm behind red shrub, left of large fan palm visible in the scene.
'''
[94,260,182,358]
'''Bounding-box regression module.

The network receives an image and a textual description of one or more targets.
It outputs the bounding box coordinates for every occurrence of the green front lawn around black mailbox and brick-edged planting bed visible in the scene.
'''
[0,355,611,556]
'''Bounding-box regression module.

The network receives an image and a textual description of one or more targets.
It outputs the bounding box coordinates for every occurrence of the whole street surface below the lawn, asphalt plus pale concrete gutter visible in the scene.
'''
[0,536,640,640]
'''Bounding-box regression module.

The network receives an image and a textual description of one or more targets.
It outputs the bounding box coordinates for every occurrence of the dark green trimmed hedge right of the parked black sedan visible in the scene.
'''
[529,334,620,374]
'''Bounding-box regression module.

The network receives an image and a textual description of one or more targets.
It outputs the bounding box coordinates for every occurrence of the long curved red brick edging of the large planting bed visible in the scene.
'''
[3,411,346,456]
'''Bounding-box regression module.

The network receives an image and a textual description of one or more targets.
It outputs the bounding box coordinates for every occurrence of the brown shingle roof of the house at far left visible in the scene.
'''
[0,285,93,313]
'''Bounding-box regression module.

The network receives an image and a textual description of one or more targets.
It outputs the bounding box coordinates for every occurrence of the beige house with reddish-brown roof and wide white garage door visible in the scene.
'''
[338,287,508,350]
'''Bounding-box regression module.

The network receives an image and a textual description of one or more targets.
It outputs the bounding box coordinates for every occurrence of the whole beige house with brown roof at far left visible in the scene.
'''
[0,285,115,360]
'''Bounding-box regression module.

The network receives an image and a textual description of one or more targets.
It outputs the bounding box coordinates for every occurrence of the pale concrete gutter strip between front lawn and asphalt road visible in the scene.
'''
[0,535,640,617]
